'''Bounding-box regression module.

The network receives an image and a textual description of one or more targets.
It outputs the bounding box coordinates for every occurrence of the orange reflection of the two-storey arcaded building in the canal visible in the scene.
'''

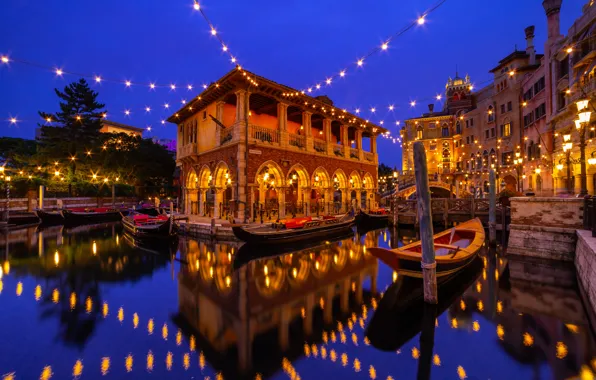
[178,231,381,378]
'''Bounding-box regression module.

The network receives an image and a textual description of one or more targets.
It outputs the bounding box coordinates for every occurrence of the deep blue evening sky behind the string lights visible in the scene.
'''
[0,0,585,166]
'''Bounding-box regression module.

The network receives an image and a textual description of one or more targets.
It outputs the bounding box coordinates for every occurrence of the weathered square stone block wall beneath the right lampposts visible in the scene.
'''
[507,197,584,261]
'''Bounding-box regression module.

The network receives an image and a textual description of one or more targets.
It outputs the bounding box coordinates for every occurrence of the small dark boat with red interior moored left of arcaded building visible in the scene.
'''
[122,213,177,239]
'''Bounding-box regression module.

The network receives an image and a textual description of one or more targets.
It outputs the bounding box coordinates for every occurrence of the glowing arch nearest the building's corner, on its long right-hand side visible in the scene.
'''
[253,161,286,220]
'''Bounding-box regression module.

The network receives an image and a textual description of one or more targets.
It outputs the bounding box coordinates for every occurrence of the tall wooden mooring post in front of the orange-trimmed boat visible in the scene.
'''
[414,141,438,304]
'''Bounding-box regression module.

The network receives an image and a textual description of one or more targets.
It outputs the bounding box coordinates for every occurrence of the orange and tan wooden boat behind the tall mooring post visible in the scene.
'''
[369,218,484,277]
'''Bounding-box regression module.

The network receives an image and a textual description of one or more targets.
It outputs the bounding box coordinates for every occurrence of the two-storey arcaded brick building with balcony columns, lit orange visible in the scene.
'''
[168,68,386,220]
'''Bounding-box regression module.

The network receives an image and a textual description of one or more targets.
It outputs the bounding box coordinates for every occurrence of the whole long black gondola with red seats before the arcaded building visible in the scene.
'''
[232,214,354,245]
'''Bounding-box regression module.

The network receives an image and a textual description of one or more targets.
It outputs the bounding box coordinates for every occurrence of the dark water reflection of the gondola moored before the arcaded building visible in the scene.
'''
[232,230,354,270]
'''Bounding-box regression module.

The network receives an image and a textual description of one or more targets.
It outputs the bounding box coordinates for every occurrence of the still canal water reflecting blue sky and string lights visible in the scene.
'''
[0,224,596,379]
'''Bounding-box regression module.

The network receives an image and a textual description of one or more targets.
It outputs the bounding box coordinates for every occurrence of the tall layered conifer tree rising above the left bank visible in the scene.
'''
[39,79,106,195]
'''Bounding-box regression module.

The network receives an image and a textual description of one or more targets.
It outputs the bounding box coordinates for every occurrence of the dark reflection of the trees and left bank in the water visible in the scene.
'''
[0,224,176,348]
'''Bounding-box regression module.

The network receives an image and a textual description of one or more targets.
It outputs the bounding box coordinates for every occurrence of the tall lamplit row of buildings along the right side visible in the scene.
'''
[401,0,596,196]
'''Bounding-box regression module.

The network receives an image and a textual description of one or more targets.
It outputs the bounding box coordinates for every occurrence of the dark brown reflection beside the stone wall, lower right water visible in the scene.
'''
[448,251,596,379]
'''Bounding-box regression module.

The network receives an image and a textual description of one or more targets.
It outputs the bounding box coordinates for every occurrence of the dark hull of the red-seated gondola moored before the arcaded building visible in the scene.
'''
[232,218,354,245]
